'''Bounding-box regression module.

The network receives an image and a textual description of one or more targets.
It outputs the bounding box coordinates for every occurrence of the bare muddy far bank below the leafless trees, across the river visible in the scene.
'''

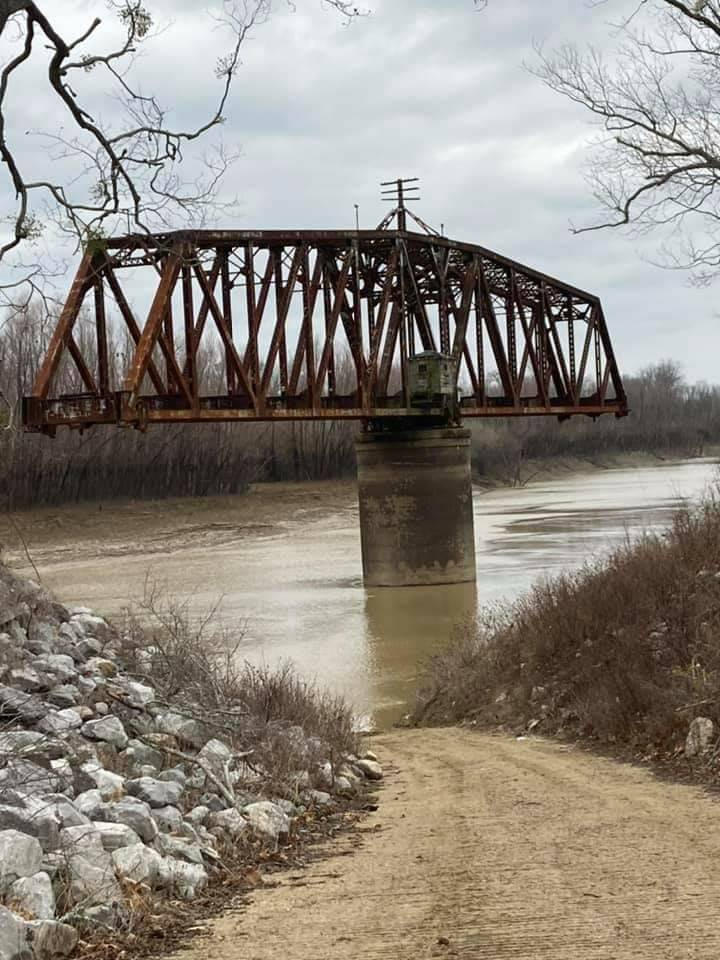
[0,446,720,573]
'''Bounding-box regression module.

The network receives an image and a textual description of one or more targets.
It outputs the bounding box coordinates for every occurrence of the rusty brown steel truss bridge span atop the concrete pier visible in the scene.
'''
[23,230,627,433]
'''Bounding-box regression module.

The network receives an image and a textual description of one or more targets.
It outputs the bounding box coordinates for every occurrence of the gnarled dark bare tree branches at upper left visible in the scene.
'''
[0,0,362,304]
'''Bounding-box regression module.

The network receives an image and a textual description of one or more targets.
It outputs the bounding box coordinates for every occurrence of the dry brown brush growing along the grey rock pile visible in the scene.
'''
[120,584,359,796]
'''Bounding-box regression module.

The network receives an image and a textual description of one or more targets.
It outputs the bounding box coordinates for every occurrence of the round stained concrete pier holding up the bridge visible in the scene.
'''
[356,427,475,587]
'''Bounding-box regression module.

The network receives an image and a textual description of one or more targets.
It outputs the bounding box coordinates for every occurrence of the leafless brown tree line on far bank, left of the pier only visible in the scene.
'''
[0,311,357,509]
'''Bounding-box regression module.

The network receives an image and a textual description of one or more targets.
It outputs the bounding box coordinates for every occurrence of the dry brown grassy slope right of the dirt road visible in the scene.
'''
[415,495,720,755]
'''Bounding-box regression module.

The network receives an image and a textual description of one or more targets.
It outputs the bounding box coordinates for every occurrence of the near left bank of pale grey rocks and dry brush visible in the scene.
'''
[0,566,382,960]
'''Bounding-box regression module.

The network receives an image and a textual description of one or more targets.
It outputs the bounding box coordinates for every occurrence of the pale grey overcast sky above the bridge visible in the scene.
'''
[7,0,720,381]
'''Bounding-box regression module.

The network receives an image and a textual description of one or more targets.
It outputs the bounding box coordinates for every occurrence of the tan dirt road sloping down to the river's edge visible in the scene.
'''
[177,730,720,960]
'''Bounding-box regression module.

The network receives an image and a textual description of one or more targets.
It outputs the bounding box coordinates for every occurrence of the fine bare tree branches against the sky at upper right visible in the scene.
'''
[537,0,720,282]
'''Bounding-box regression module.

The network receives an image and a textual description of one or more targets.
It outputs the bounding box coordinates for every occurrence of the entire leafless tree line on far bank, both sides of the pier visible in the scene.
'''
[0,310,720,509]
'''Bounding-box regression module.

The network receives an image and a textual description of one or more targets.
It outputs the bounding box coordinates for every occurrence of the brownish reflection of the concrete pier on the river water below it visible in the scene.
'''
[365,583,478,726]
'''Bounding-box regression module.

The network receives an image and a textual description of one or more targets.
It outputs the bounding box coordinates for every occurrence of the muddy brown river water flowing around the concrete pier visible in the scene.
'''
[0,460,717,727]
